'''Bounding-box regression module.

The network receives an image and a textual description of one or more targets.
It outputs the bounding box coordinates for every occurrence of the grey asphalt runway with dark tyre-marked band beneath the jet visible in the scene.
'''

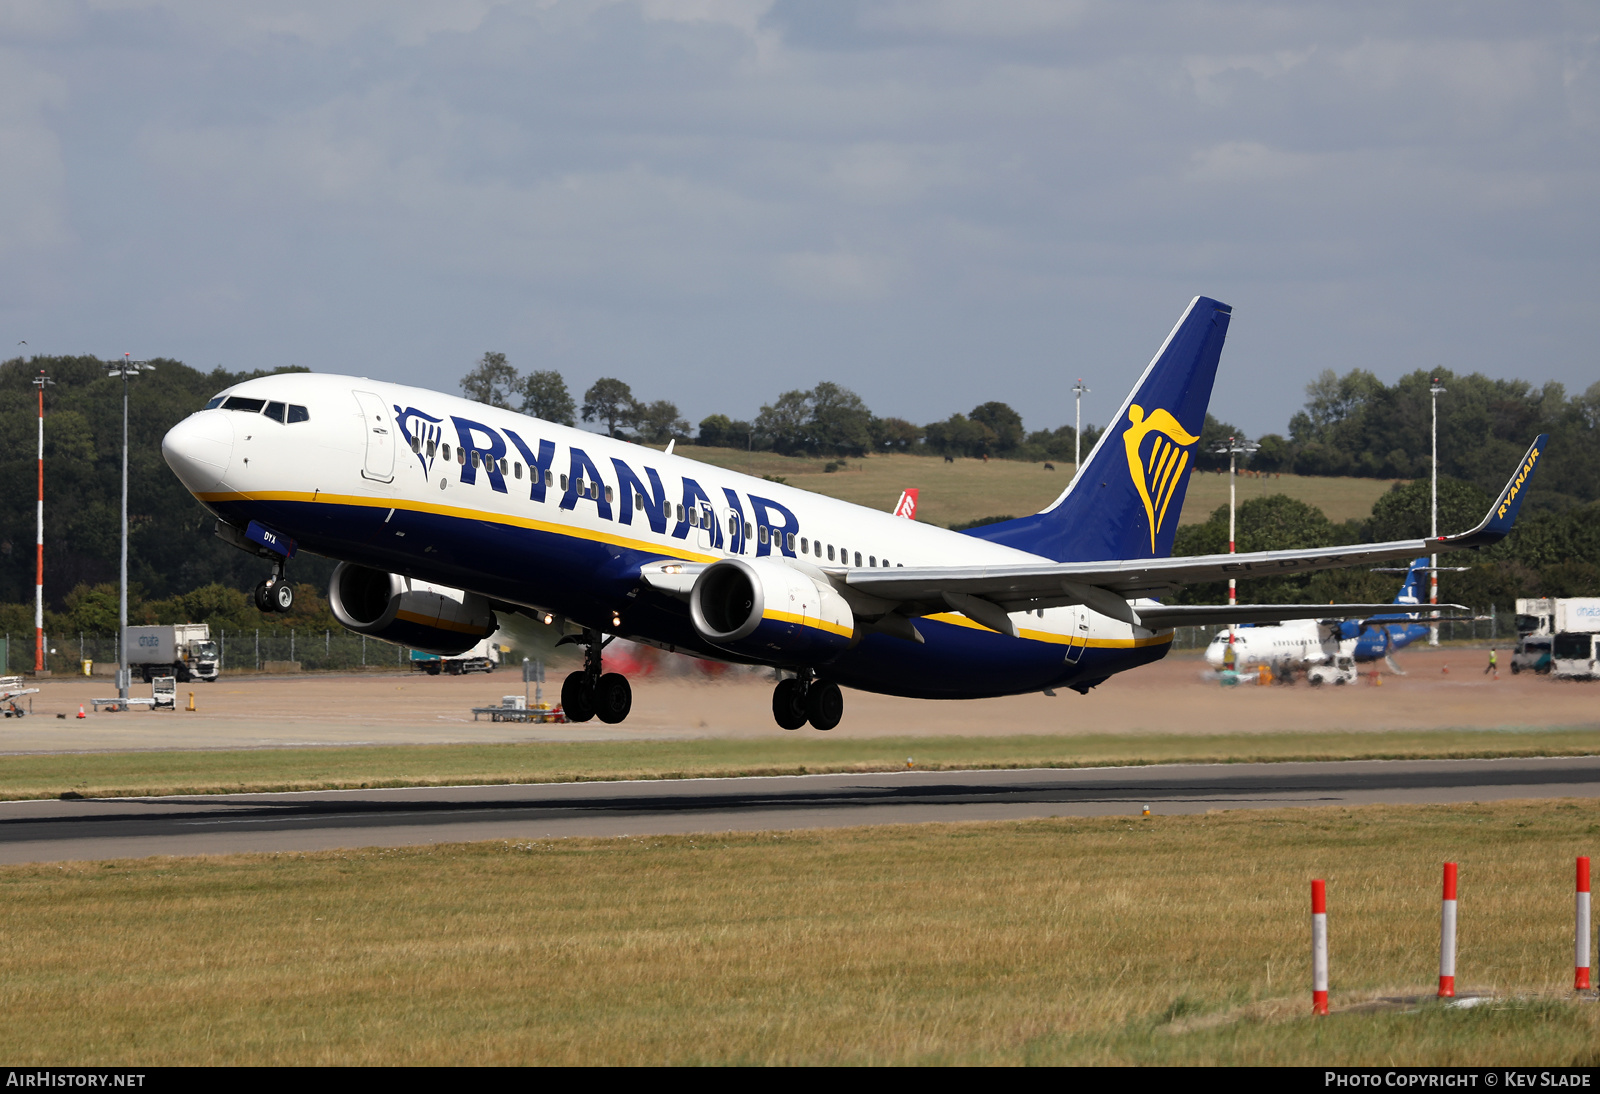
[0,757,1600,862]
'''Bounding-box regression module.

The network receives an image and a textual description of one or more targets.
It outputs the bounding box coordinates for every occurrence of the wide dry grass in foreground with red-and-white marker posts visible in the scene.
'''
[0,801,1600,1067]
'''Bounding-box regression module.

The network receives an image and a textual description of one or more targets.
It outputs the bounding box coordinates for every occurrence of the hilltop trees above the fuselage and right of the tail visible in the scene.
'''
[461,353,1600,510]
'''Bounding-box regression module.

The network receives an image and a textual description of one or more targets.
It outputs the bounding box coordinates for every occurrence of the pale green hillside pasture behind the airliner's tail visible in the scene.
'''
[656,445,1392,526]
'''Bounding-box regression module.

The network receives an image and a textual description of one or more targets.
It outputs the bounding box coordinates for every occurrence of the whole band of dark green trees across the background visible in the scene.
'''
[0,345,1600,635]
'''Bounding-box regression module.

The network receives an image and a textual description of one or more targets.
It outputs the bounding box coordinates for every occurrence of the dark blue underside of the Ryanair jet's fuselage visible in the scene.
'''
[211,501,1170,699]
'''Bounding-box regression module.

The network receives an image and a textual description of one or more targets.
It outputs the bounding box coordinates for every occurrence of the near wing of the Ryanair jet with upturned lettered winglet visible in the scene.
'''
[830,433,1547,625]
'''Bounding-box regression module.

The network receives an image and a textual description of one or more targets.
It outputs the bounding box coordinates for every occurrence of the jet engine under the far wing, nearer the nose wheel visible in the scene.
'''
[328,563,496,657]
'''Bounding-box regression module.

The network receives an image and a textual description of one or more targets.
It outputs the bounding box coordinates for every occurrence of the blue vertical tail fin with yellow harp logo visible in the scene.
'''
[968,296,1232,561]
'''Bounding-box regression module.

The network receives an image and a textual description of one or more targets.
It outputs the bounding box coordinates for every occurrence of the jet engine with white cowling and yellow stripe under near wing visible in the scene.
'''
[690,558,856,665]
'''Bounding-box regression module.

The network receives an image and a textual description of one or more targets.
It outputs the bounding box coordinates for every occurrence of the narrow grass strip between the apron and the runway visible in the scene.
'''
[21,726,1600,800]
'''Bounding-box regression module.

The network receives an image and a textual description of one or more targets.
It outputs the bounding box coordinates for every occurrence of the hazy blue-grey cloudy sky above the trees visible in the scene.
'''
[0,0,1600,435]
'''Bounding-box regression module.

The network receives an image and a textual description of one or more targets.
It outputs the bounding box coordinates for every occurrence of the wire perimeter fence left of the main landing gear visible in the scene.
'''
[5,627,411,677]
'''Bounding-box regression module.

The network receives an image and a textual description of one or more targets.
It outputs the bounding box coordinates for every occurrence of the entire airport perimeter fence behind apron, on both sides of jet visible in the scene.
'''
[3,606,1517,675]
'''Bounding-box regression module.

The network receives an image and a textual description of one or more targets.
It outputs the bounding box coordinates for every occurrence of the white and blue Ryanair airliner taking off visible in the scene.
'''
[162,297,1544,729]
